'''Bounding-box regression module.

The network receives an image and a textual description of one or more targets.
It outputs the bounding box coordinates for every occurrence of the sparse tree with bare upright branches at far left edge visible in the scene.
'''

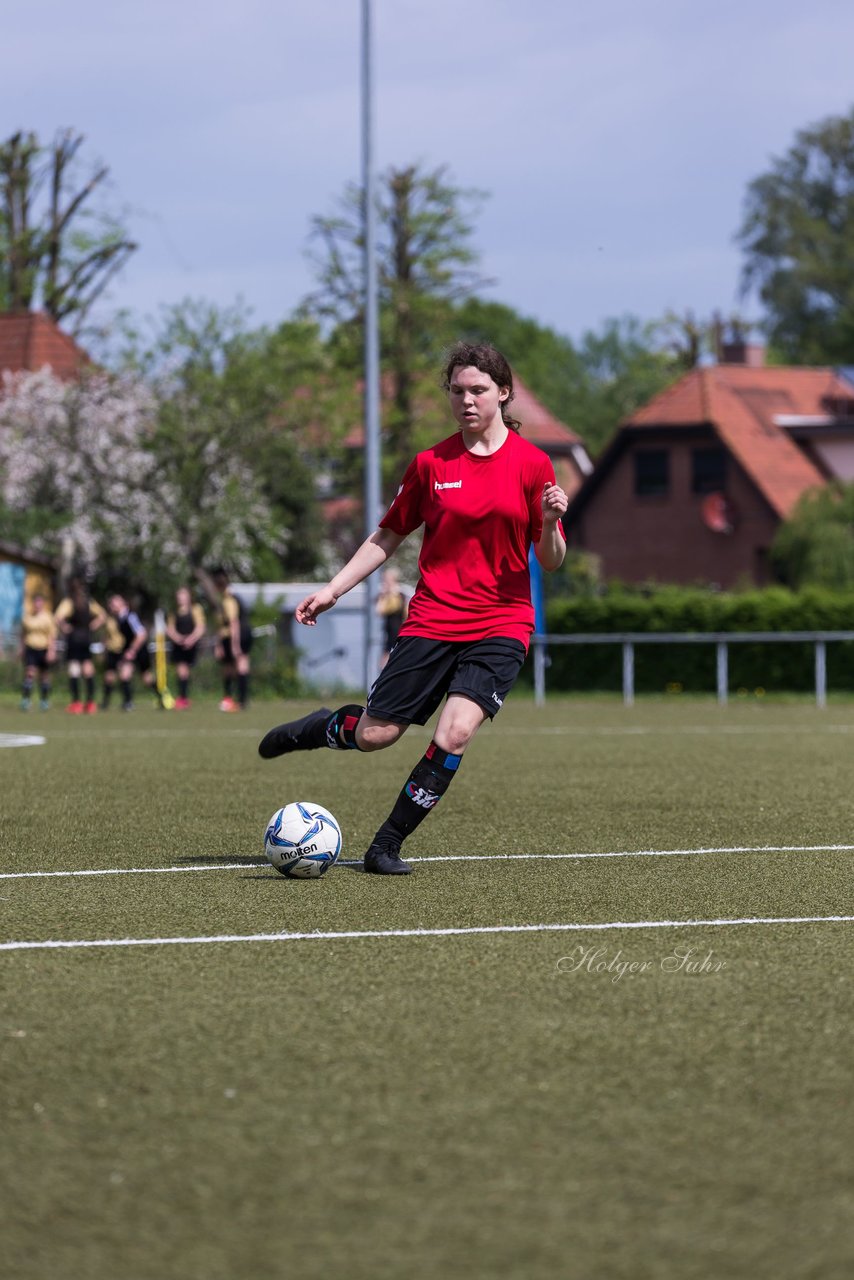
[0,129,137,330]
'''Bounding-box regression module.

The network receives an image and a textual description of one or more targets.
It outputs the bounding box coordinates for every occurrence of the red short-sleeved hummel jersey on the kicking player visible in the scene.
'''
[380,431,563,648]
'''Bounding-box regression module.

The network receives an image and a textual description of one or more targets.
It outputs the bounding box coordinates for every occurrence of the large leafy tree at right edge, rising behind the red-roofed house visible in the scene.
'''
[737,110,854,364]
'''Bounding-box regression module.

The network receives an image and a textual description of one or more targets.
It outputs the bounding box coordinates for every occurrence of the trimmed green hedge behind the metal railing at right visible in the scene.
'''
[537,586,854,692]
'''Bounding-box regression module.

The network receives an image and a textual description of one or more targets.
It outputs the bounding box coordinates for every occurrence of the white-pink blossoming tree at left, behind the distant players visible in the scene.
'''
[0,370,307,593]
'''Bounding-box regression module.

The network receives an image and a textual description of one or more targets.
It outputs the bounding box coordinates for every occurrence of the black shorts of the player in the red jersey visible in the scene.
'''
[367,636,525,724]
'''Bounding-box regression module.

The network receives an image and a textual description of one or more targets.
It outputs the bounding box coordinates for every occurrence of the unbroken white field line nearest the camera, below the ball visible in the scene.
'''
[0,915,854,951]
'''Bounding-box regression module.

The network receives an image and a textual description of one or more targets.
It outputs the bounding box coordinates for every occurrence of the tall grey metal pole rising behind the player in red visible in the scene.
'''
[361,0,382,689]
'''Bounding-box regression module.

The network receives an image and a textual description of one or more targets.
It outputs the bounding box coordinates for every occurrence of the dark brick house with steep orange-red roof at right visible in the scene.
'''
[565,347,854,588]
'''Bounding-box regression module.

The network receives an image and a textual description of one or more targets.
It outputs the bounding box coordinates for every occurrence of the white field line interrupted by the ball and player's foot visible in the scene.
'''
[0,845,854,879]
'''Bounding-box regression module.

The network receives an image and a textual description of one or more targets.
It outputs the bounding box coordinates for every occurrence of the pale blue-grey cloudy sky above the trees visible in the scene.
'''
[6,0,854,337]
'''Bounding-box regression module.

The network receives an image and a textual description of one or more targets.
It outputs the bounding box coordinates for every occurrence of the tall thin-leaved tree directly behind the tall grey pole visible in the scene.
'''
[303,165,485,476]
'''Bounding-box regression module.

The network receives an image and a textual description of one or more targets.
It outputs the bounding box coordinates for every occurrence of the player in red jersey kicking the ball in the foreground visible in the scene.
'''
[259,343,567,876]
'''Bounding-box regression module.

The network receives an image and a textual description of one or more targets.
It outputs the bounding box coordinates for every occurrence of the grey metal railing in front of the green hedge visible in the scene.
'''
[531,631,854,707]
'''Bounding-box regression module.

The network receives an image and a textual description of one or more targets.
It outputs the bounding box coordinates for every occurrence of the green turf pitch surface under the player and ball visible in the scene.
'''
[0,698,854,1280]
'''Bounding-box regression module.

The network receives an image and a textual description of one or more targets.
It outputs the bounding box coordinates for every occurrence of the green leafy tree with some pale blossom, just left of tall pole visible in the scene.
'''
[119,302,338,591]
